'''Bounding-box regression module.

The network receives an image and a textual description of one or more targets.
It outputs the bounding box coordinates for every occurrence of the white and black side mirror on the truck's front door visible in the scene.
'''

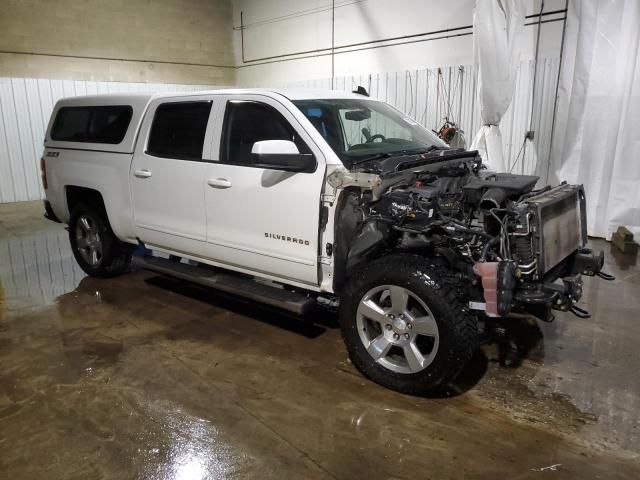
[251,140,316,173]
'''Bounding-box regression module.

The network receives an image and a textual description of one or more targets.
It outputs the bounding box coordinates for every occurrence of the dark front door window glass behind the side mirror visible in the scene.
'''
[221,101,310,165]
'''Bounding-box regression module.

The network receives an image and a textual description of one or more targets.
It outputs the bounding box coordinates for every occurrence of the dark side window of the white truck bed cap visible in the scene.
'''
[51,105,133,144]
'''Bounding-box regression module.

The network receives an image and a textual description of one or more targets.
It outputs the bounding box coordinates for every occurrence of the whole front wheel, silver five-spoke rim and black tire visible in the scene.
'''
[340,255,478,395]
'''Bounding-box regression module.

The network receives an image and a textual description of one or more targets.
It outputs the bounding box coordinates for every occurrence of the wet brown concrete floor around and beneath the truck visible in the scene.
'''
[0,202,640,479]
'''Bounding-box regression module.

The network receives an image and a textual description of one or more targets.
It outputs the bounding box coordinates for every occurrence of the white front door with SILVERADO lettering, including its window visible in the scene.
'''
[205,95,326,286]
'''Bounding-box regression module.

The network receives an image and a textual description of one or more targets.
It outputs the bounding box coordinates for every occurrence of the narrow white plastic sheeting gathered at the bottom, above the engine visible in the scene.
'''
[471,0,525,172]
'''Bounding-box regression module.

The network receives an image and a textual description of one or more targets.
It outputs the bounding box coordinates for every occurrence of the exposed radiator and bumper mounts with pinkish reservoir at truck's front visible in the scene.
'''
[472,184,604,320]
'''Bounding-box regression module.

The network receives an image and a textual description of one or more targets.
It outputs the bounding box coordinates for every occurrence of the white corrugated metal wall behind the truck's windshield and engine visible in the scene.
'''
[262,58,559,178]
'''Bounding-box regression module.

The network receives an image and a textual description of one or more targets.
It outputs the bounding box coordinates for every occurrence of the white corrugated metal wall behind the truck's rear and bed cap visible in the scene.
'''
[0,77,220,203]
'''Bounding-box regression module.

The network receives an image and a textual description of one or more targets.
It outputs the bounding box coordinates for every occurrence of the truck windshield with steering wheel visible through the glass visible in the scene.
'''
[293,99,447,168]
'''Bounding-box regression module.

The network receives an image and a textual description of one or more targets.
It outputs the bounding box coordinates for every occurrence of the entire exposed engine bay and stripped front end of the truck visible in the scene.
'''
[329,150,607,321]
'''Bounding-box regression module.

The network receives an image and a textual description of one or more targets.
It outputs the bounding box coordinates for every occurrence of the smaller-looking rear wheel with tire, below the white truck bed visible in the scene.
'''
[69,203,131,277]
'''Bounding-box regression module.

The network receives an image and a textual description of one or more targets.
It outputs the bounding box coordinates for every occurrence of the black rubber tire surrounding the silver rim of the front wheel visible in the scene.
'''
[339,254,478,395]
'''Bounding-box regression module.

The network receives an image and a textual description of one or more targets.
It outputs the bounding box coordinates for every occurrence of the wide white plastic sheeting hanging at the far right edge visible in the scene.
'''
[549,0,640,239]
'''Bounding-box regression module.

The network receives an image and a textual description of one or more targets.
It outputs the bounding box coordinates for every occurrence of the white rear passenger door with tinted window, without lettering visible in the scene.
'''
[130,96,215,256]
